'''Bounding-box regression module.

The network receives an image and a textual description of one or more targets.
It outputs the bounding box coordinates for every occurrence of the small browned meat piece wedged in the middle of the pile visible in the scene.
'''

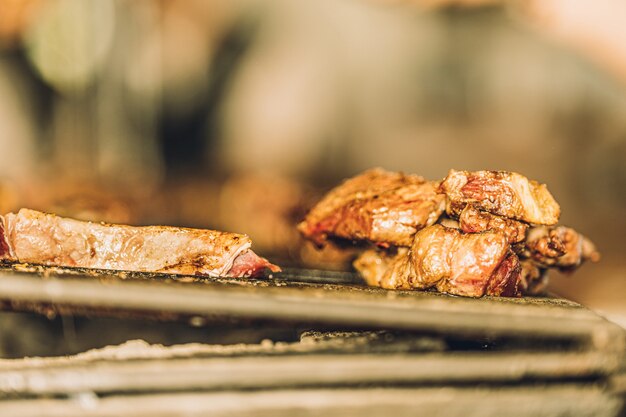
[459,204,528,244]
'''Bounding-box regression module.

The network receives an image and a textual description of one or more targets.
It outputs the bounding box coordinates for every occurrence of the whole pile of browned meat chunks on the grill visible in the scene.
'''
[298,169,600,297]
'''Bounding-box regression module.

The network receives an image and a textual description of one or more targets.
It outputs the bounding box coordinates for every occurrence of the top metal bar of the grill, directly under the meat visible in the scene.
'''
[0,271,624,349]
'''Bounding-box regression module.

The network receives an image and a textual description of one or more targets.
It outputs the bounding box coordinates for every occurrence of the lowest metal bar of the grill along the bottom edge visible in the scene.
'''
[0,384,622,417]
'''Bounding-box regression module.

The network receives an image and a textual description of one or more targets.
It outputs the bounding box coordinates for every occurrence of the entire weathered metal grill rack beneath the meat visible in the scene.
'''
[0,266,625,417]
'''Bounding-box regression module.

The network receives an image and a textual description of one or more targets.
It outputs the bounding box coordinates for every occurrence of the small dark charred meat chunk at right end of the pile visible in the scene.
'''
[520,226,600,269]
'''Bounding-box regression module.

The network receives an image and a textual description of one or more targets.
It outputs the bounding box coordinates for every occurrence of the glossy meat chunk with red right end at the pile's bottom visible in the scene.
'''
[355,225,521,297]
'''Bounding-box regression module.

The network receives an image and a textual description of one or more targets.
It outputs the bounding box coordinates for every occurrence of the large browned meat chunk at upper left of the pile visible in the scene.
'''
[298,168,445,246]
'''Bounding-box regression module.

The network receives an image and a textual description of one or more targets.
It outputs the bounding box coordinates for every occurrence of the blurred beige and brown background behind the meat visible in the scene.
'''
[0,0,626,332]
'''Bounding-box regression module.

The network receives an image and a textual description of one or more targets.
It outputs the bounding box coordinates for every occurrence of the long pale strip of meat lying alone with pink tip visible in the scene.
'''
[0,209,280,277]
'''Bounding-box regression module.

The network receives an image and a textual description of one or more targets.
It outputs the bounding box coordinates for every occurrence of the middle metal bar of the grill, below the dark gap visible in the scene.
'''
[0,343,619,395]
